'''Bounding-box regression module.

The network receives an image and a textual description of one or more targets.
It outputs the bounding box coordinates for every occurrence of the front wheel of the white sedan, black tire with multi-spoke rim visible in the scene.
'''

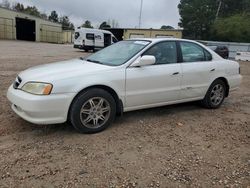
[69,88,116,133]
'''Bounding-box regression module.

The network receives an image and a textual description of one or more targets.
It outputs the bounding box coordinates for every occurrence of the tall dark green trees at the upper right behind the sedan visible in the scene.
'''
[178,0,250,42]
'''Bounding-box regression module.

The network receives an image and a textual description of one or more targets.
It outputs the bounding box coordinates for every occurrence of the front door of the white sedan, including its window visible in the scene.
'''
[125,41,182,109]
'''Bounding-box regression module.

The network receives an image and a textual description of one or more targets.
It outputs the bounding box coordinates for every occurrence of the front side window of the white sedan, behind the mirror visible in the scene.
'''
[144,41,177,64]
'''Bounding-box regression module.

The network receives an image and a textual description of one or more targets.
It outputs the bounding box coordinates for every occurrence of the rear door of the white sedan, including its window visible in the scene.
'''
[179,41,217,99]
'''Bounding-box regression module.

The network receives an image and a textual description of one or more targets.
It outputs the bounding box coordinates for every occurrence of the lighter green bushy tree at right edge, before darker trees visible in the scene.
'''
[211,14,250,42]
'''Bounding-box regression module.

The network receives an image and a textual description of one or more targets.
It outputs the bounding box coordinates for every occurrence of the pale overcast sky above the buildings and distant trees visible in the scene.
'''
[0,0,180,29]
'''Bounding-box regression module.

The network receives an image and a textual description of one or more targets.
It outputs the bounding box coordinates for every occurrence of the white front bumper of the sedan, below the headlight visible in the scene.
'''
[7,85,75,124]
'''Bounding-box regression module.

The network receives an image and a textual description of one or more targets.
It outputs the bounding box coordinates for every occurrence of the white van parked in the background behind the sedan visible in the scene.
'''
[74,27,118,52]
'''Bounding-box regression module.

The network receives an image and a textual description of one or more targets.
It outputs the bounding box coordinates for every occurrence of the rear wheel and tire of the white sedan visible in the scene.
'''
[202,79,226,109]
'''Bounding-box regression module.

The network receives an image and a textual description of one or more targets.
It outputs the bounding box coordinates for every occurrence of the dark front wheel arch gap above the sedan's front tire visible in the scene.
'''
[67,85,123,119]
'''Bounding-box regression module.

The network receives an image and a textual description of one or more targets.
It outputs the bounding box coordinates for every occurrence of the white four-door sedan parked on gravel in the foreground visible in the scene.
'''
[7,38,241,133]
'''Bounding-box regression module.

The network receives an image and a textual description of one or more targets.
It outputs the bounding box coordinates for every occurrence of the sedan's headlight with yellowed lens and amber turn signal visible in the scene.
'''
[21,82,53,95]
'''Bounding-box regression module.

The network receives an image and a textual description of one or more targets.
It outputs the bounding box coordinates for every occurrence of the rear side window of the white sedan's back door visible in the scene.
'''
[180,42,212,62]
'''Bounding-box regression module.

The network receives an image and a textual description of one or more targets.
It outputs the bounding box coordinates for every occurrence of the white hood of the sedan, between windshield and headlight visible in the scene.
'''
[19,59,112,82]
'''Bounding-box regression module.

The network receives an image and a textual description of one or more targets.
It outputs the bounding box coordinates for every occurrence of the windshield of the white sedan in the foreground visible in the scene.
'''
[84,40,150,66]
